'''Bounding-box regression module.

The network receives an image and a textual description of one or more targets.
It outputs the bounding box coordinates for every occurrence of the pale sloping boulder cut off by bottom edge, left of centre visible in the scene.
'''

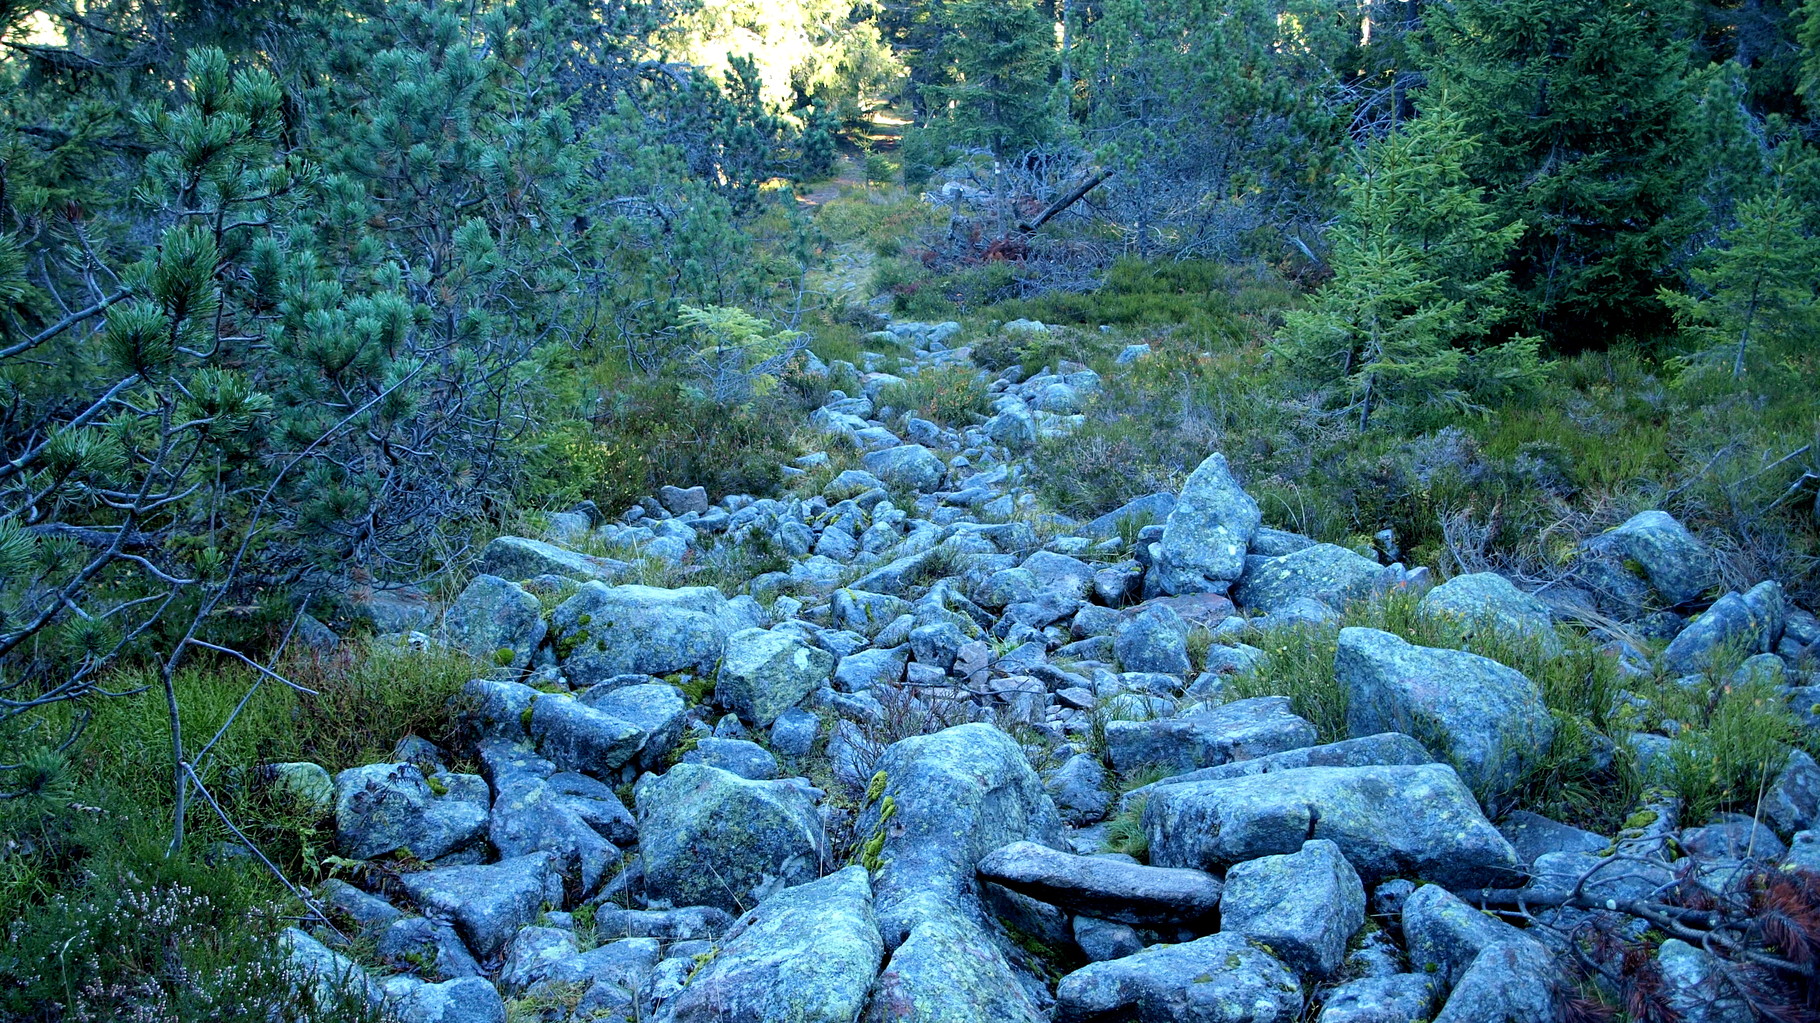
[659,866,885,1023]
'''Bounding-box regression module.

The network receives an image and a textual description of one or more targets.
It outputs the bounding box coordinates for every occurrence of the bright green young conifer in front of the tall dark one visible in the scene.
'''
[1278,104,1538,430]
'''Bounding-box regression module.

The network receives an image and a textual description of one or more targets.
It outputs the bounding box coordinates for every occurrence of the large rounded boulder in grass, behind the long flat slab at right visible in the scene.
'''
[1334,628,1554,792]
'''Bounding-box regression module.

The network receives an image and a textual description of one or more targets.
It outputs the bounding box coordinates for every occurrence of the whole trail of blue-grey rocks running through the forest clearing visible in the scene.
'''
[277,324,1820,1023]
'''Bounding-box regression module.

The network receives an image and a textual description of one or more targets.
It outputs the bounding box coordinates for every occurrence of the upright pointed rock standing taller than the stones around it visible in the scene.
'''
[1152,453,1261,593]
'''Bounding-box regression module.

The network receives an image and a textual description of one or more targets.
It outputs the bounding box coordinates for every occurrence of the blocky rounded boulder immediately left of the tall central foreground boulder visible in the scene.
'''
[635,765,826,912]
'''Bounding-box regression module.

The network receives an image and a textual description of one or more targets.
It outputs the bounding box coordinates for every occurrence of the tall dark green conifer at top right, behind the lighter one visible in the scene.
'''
[1427,0,1705,340]
